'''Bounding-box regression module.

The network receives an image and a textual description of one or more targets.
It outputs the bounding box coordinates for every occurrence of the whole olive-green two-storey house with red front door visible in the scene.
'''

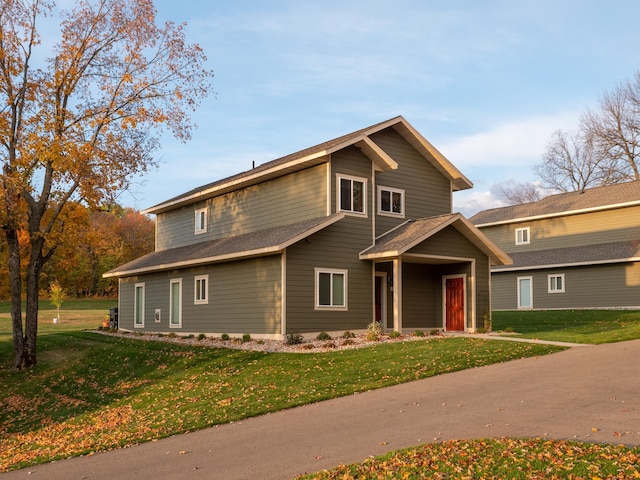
[105,117,510,338]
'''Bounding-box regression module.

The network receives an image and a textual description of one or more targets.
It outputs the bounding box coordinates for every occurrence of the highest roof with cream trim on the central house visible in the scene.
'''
[142,116,473,214]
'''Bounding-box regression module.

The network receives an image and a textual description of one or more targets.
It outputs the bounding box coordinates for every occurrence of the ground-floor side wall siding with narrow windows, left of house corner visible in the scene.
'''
[119,255,282,335]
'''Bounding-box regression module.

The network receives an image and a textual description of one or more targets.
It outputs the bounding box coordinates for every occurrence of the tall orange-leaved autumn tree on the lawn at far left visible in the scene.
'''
[0,0,212,369]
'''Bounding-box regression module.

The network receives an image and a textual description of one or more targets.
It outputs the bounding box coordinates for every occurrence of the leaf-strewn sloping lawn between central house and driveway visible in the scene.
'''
[0,332,561,471]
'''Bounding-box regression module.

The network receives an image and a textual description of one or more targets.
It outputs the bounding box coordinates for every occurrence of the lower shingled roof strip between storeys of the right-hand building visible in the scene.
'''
[494,240,640,272]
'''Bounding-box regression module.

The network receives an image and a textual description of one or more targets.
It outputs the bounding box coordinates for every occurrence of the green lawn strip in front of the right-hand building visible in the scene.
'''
[493,310,640,344]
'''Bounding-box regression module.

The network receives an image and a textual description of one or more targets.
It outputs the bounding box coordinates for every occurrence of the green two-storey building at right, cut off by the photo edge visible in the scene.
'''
[471,181,640,310]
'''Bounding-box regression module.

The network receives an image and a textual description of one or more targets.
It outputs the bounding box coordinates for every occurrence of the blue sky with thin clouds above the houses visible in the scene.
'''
[121,0,640,215]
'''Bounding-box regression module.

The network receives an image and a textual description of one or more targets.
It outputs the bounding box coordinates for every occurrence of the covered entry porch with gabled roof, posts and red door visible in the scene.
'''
[360,214,510,332]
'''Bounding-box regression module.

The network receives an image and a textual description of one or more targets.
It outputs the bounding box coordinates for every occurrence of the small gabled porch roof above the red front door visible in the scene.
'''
[360,213,511,265]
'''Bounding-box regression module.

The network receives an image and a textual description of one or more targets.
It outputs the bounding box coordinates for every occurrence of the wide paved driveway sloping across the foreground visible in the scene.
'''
[5,340,640,480]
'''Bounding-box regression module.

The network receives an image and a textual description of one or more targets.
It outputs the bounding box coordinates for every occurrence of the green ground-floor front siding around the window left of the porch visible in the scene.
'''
[286,217,373,333]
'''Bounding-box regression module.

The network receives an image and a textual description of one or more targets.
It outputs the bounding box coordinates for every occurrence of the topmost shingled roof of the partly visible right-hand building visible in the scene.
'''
[470,181,640,227]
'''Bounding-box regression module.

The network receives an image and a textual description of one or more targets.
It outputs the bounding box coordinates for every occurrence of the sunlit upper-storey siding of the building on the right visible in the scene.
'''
[481,206,640,253]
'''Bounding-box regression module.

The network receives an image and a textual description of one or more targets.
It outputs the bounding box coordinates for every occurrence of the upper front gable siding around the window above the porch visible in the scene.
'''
[371,129,451,235]
